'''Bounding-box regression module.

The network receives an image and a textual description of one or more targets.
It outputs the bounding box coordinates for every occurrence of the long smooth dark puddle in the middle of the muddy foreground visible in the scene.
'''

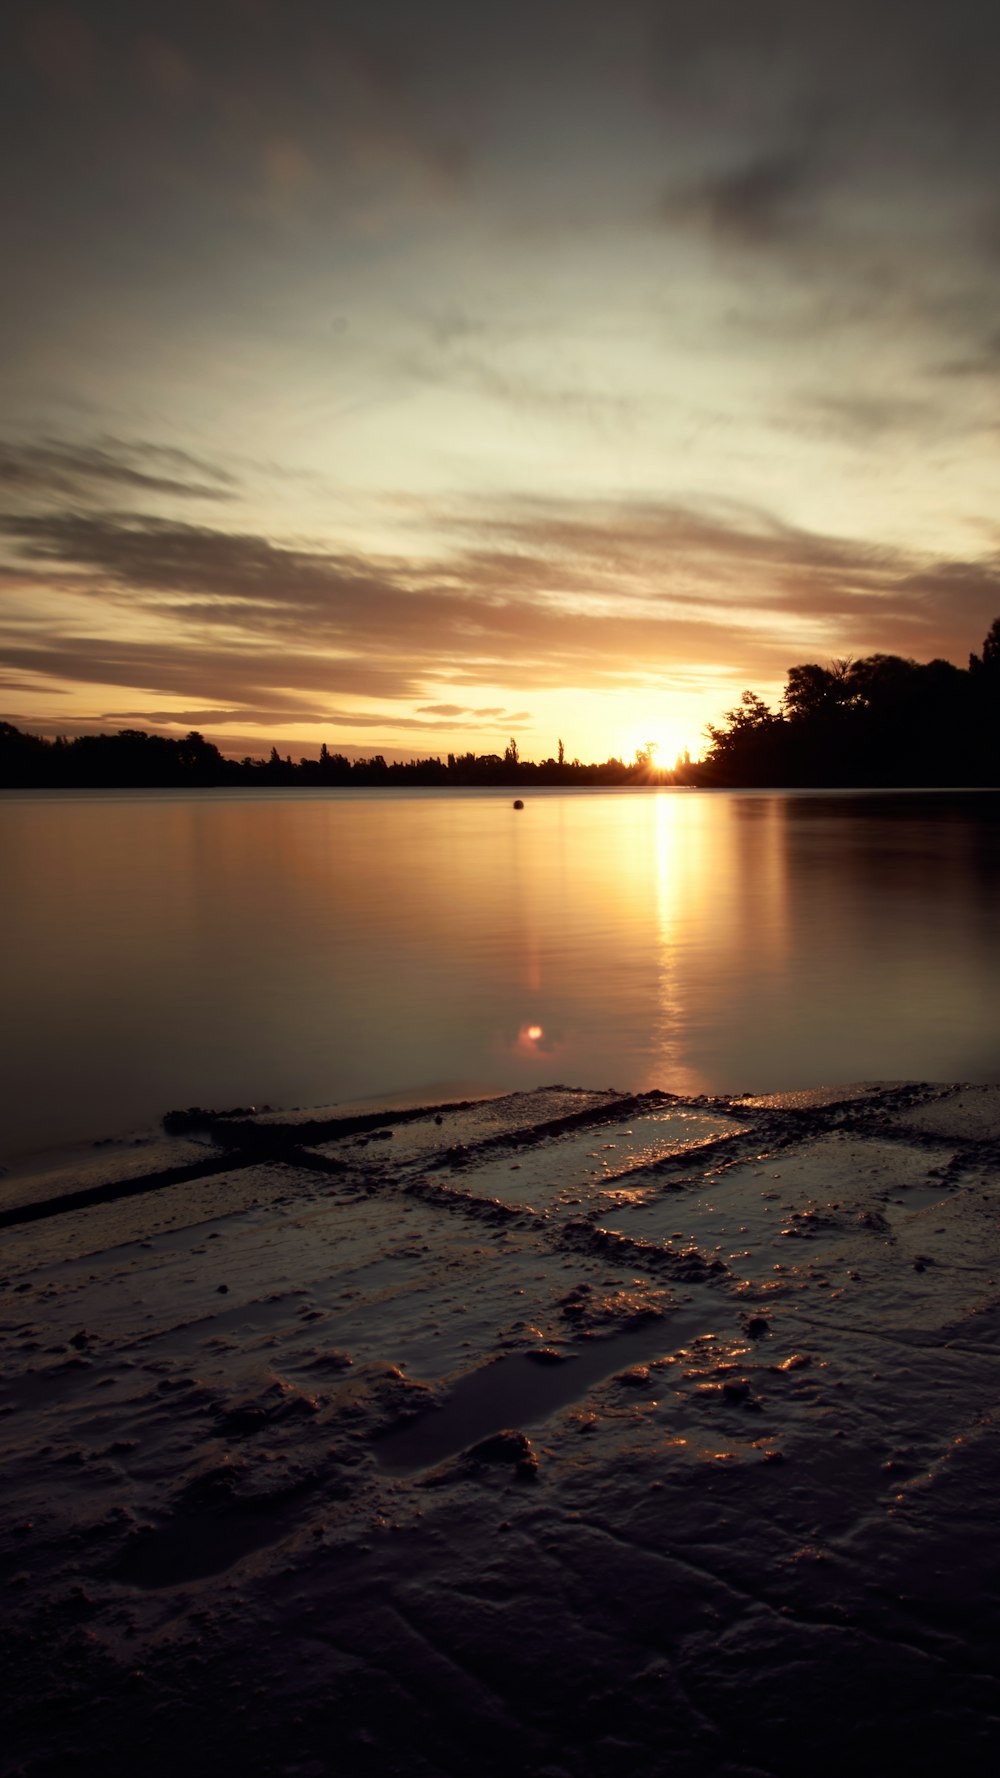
[375,1309,705,1476]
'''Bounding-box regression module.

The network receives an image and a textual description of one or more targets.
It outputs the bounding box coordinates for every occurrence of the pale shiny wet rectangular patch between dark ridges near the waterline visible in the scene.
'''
[423,1109,747,1209]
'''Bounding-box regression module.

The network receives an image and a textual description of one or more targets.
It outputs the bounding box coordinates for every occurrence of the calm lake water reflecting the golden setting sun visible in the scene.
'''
[0,791,1000,1161]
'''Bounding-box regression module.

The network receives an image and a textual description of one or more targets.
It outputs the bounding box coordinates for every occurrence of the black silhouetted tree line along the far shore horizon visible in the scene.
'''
[0,617,1000,789]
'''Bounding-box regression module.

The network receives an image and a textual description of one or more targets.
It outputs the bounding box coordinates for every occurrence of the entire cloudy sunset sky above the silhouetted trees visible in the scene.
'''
[0,0,1000,763]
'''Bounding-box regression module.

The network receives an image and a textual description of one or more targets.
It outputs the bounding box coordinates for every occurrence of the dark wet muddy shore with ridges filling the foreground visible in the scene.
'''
[0,1086,1000,1778]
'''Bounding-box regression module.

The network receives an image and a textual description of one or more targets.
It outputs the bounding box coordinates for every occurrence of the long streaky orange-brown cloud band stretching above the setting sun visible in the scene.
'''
[0,500,979,661]
